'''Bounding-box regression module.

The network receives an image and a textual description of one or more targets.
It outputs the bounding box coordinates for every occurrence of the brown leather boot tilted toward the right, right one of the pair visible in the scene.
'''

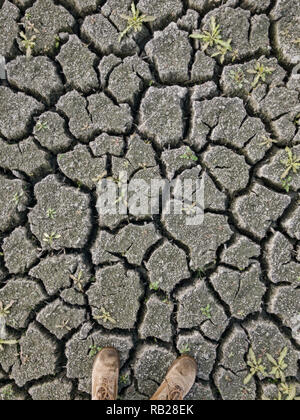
[151,356,197,401]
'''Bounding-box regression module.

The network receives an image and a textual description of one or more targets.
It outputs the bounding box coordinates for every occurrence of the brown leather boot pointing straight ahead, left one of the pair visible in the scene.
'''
[92,347,120,401]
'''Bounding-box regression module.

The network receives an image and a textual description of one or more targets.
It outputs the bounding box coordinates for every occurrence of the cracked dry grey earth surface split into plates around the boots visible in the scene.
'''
[0,0,300,400]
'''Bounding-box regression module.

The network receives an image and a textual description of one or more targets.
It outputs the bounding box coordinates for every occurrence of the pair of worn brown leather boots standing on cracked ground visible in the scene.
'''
[92,347,197,401]
